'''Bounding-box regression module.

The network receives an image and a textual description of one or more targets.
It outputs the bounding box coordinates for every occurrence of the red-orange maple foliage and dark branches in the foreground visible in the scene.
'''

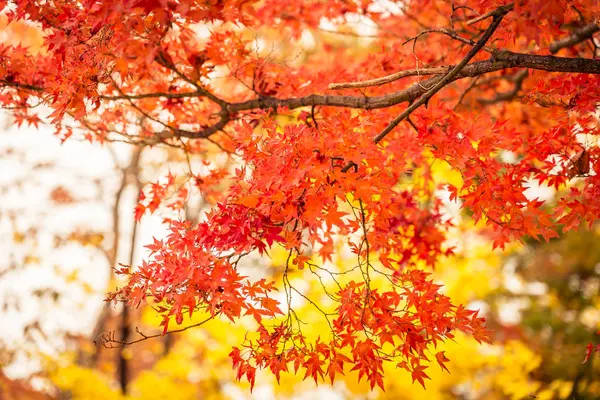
[0,0,600,394]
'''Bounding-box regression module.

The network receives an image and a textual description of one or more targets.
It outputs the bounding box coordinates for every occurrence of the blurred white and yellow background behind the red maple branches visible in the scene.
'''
[0,12,600,400]
